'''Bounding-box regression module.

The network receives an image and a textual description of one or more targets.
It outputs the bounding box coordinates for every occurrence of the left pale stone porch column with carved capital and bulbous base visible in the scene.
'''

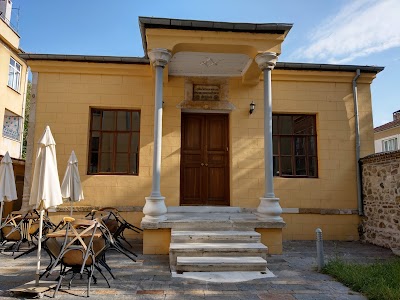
[143,48,171,222]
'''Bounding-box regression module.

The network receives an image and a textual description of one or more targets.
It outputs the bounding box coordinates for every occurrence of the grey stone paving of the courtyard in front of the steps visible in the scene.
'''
[0,241,395,300]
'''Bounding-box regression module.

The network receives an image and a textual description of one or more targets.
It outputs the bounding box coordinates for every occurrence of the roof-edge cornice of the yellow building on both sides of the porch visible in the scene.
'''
[19,53,384,83]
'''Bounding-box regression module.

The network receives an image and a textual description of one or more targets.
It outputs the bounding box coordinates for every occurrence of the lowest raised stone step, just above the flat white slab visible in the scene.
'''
[176,256,267,273]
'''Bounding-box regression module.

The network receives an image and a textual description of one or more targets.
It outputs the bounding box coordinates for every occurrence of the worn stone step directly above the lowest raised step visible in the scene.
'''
[169,243,268,271]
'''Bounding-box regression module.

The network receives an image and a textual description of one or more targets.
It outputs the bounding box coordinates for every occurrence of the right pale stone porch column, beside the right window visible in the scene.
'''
[255,52,283,222]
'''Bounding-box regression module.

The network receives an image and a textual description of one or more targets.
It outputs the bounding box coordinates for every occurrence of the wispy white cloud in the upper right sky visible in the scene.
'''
[294,0,400,63]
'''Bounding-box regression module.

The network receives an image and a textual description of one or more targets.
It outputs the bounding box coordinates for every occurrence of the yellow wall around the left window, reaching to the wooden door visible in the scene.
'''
[34,63,183,210]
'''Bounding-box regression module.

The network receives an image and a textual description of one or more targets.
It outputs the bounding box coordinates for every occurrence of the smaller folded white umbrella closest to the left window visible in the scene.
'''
[61,150,84,216]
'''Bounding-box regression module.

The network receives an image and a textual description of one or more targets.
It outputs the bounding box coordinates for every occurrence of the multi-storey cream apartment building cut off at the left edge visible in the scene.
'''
[0,0,28,215]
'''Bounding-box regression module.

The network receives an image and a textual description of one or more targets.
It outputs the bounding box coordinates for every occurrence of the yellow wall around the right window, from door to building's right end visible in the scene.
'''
[230,70,374,239]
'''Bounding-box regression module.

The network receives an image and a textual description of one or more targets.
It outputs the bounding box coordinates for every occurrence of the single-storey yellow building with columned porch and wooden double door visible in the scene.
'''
[20,17,383,253]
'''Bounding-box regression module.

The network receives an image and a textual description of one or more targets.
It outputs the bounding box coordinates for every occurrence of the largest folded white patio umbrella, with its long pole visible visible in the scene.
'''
[29,126,62,285]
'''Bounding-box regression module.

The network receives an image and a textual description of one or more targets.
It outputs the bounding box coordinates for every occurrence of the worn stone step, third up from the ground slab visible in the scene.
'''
[171,229,261,243]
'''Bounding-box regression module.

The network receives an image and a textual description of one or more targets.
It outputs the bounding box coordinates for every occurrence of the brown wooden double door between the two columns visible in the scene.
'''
[180,113,230,206]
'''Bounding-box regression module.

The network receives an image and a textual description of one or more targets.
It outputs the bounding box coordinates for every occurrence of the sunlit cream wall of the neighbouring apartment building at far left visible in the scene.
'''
[0,31,27,158]
